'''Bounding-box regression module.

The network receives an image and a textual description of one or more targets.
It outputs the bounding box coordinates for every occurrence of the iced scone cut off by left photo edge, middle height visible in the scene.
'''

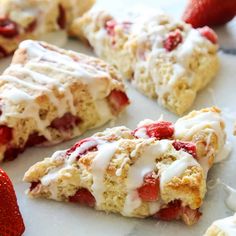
[0,40,129,160]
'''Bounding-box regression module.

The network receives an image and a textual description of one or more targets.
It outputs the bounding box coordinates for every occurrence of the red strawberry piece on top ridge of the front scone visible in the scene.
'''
[133,121,174,140]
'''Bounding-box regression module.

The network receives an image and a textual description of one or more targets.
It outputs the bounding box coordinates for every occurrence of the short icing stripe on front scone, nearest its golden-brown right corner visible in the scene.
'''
[160,151,199,190]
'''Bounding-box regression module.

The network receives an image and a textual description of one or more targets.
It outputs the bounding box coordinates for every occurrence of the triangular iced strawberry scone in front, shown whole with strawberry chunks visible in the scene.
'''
[24,108,225,225]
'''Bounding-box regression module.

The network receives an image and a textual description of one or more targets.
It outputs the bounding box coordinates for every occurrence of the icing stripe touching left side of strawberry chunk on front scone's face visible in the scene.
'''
[123,140,172,216]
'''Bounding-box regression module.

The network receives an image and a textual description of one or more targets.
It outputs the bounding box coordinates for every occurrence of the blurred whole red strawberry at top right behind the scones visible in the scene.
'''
[183,0,236,28]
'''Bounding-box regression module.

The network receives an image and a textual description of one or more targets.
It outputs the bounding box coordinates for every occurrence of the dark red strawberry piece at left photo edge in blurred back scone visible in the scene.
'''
[0,18,18,38]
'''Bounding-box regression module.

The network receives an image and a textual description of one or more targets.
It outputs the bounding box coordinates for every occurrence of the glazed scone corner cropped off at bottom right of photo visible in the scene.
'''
[204,214,236,236]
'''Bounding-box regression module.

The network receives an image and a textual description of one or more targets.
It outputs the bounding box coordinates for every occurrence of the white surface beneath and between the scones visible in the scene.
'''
[0,0,236,236]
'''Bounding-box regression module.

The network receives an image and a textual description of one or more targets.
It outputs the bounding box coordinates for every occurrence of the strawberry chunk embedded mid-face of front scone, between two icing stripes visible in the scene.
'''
[138,173,160,202]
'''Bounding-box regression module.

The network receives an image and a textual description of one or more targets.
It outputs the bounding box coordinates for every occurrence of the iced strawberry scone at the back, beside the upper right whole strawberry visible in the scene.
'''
[70,10,218,115]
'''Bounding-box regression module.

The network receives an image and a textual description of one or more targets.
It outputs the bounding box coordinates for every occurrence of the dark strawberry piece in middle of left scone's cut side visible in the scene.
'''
[50,112,81,131]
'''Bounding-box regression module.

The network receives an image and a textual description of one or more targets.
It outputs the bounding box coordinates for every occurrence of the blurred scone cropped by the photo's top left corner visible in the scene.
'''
[0,0,95,57]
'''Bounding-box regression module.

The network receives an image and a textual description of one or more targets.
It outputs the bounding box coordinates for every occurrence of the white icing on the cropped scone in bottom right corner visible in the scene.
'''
[213,214,236,236]
